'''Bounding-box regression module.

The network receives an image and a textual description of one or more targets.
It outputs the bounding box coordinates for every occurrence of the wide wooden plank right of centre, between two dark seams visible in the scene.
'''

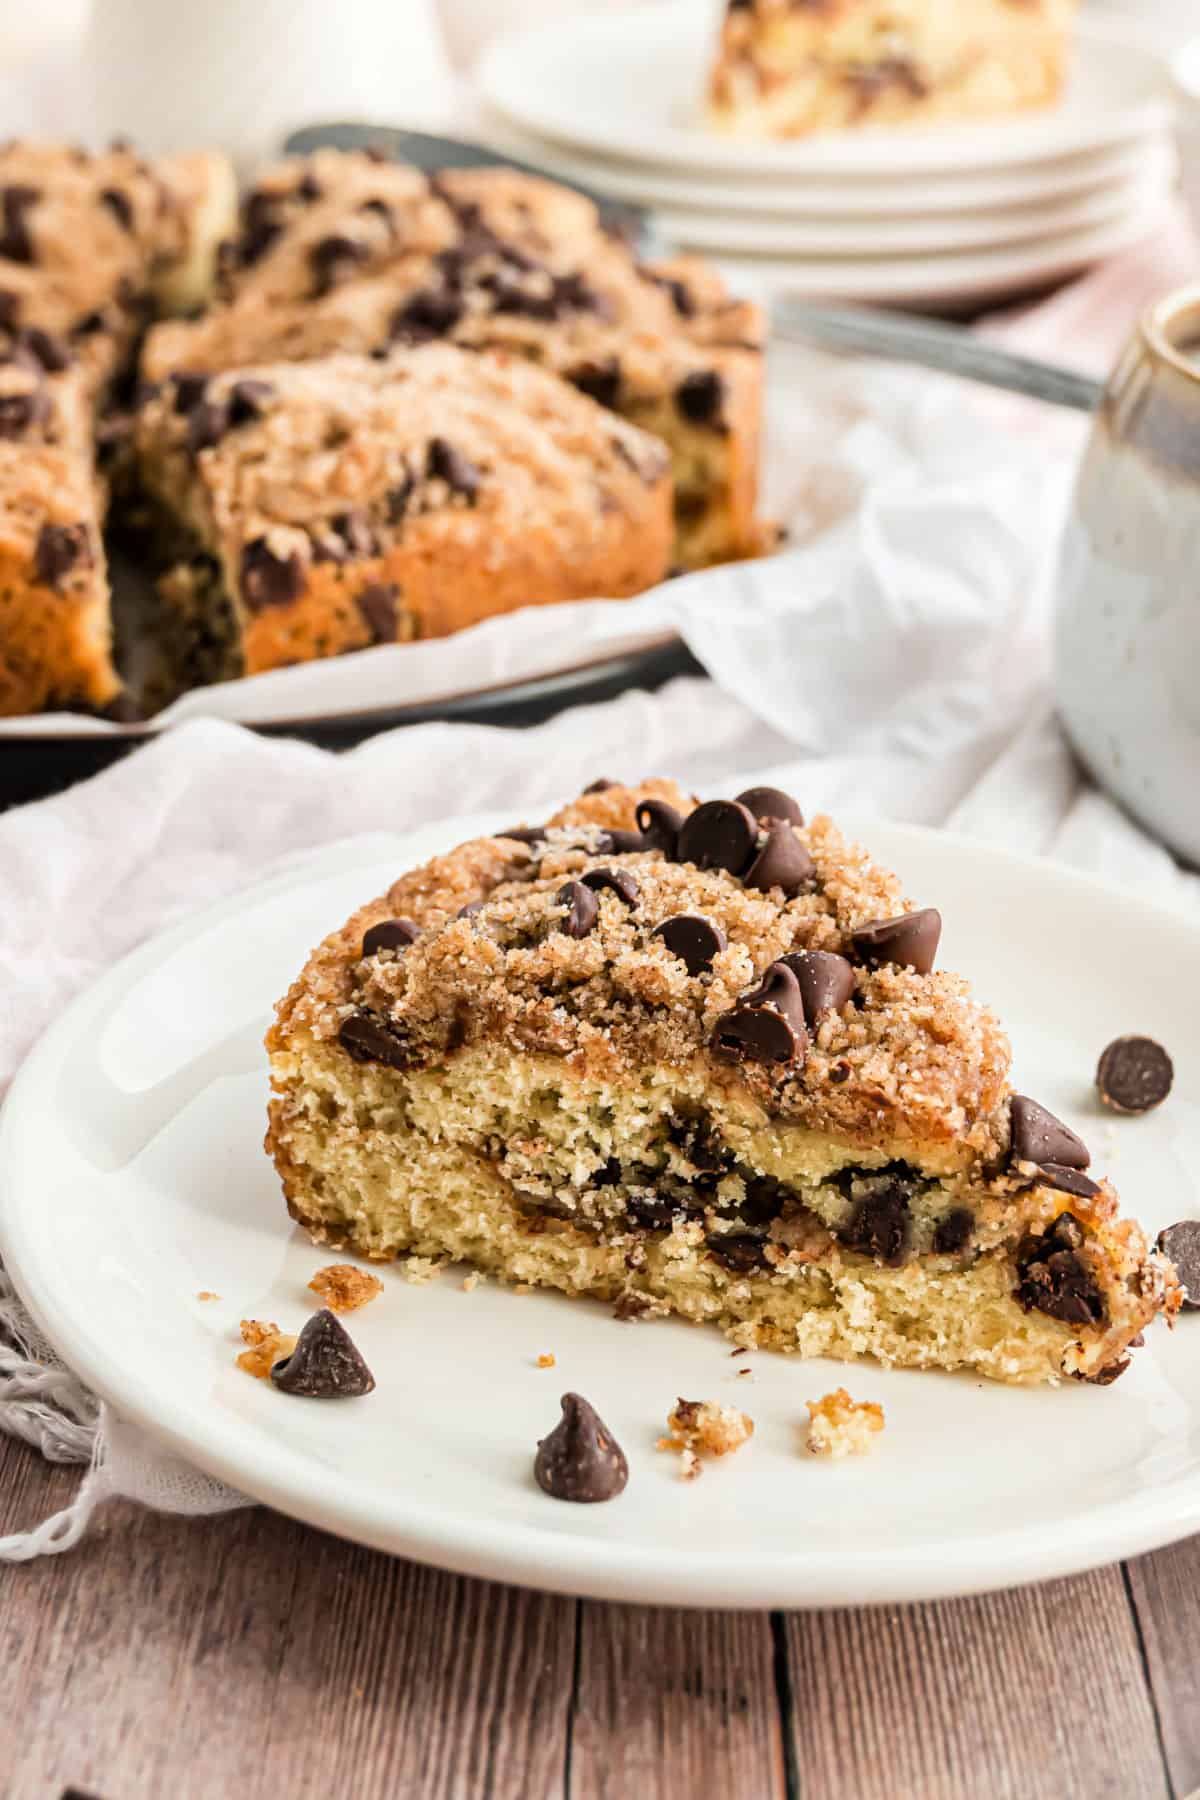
[786,1568,1169,1800]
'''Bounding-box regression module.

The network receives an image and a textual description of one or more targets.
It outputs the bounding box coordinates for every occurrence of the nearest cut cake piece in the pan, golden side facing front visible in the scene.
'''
[137,344,671,684]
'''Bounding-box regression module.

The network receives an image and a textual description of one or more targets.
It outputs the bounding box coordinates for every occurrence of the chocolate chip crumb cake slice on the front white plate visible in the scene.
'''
[266,781,1180,1382]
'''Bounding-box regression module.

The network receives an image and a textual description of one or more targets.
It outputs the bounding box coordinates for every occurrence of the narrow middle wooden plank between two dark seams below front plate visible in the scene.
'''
[569,1600,786,1800]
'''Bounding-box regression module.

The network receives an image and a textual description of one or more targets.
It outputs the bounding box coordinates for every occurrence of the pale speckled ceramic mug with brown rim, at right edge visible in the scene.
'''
[1056,286,1200,864]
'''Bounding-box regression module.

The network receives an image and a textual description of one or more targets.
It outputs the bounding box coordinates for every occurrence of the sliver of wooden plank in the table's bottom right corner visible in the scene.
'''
[1126,1537,1200,1795]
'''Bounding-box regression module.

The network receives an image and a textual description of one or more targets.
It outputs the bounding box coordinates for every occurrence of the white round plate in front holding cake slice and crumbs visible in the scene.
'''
[0,819,1200,1607]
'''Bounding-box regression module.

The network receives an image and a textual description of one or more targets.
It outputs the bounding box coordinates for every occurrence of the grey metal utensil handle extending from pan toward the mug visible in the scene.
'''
[772,299,1105,412]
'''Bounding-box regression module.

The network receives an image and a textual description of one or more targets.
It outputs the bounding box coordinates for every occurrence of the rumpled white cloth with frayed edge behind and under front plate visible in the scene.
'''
[0,228,1200,1561]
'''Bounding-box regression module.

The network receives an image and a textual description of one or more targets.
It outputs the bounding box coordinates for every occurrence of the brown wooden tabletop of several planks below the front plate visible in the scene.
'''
[0,1438,1200,1800]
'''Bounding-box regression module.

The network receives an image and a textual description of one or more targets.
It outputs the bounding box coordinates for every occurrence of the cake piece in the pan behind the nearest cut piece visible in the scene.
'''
[144,151,774,567]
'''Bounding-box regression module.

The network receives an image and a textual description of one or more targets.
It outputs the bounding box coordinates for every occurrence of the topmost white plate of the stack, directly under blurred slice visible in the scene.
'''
[479,0,1169,176]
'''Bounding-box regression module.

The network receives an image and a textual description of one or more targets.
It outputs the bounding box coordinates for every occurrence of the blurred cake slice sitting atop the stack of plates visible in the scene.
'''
[709,0,1076,137]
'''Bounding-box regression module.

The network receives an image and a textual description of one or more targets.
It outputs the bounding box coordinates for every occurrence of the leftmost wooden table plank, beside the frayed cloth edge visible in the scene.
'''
[0,1440,576,1800]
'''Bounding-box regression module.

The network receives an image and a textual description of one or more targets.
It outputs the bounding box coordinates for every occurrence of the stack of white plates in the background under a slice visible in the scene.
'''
[479,0,1177,308]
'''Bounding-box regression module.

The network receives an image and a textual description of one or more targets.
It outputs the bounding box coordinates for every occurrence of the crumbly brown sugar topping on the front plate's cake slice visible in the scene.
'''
[269,781,1009,1159]
